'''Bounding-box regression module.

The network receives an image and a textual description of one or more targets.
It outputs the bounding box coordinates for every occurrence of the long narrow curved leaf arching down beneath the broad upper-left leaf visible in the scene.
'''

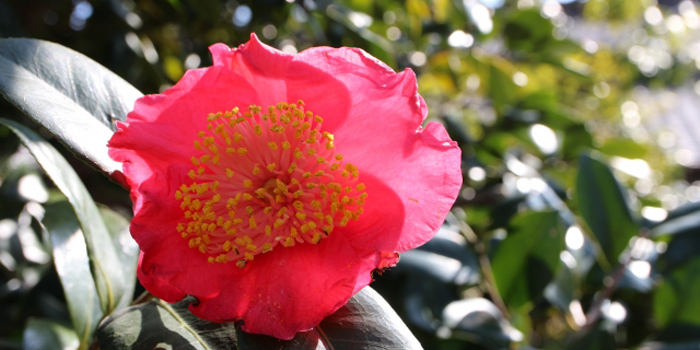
[0,118,124,314]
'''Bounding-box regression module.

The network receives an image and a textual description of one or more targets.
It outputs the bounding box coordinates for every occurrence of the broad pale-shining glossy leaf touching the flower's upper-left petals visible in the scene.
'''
[0,39,141,174]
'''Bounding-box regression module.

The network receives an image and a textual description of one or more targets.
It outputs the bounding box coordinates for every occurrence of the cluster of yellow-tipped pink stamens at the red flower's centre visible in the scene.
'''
[175,100,367,267]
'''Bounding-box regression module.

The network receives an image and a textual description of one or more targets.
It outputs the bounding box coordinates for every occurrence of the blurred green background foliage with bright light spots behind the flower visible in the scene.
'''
[0,0,700,350]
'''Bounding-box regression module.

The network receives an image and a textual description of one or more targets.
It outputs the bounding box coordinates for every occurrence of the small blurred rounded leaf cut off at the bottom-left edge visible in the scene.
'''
[22,318,79,350]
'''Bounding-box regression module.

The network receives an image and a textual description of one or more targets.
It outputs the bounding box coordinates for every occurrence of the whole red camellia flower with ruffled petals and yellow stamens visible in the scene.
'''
[109,35,462,339]
